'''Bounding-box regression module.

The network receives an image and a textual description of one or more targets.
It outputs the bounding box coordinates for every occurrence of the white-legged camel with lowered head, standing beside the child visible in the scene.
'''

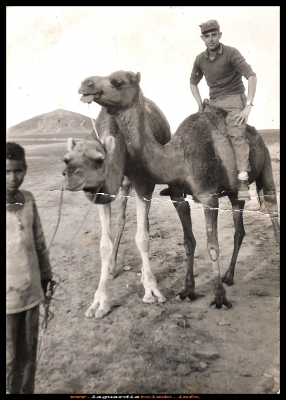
[63,92,171,318]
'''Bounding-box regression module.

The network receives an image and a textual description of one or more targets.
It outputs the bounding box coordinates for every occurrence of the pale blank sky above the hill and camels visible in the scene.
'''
[6,6,280,132]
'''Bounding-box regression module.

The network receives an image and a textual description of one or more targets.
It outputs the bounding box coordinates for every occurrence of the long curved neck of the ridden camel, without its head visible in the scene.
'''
[116,91,183,183]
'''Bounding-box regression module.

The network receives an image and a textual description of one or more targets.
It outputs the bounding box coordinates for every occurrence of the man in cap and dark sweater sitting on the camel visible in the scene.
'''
[160,20,257,200]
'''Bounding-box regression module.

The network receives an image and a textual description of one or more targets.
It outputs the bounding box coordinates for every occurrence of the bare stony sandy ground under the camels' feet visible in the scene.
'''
[15,133,280,395]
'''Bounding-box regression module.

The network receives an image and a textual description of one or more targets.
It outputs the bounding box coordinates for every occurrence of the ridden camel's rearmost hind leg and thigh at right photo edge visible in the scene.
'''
[256,148,280,245]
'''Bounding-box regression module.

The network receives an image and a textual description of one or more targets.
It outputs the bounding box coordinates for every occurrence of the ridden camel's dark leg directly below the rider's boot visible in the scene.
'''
[222,196,245,286]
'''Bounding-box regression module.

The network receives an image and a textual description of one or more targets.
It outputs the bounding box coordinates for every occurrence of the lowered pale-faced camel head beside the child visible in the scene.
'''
[63,136,114,194]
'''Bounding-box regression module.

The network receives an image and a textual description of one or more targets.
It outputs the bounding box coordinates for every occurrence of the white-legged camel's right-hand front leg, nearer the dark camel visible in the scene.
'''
[135,186,166,303]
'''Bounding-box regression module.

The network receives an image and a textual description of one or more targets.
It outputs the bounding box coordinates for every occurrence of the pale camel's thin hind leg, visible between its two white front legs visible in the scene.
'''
[108,176,132,279]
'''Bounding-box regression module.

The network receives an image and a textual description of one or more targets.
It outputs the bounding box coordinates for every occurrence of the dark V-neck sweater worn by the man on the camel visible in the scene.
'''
[190,44,256,99]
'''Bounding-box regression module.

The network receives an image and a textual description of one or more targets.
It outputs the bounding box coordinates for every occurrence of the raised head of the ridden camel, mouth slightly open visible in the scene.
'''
[78,71,140,114]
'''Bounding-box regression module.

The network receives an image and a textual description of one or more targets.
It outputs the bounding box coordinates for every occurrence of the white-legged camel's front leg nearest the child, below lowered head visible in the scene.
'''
[85,203,113,318]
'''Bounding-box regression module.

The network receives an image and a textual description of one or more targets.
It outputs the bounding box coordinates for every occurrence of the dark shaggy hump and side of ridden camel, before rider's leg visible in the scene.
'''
[175,109,237,192]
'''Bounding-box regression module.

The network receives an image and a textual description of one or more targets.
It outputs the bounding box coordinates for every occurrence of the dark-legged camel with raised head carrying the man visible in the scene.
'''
[79,71,279,308]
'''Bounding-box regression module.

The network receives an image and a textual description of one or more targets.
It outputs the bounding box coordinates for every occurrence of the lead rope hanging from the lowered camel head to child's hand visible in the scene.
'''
[36,185,97,365]
